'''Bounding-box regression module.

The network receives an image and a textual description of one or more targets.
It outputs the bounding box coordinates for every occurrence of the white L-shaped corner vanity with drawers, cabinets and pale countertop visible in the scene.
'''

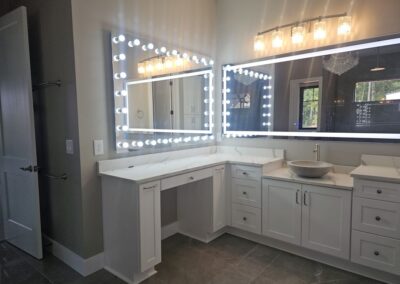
[99,151,400,283]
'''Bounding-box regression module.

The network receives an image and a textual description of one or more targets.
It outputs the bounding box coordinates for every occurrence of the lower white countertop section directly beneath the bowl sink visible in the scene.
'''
[263,166,353,190]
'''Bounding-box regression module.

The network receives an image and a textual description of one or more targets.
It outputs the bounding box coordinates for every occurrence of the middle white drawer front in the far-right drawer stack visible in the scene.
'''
[353,197,400,239]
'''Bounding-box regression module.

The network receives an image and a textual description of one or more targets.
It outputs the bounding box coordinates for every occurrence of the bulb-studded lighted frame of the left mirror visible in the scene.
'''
[110,31,215,153]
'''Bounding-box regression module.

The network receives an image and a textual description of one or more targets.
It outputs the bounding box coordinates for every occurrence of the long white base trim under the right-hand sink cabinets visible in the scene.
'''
[227,227,399,284]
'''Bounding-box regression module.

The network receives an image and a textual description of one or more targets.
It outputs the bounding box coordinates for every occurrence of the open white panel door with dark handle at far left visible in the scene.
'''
[0,7,42,259]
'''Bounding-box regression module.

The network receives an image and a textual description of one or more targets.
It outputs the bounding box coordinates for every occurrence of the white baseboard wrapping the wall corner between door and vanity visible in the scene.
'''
[44,236,104,276]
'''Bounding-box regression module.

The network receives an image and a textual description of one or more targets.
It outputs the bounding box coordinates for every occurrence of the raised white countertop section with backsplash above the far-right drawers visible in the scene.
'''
[351,155,400,182]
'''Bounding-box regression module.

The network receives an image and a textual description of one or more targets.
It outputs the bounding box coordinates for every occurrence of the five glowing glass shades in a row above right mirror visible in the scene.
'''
[254,16,351,51]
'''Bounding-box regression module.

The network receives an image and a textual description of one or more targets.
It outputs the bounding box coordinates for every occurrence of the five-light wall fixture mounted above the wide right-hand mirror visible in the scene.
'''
[254,13,352,51]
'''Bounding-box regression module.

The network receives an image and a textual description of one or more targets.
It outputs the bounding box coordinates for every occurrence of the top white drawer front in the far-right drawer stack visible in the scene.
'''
[354,179,400,202]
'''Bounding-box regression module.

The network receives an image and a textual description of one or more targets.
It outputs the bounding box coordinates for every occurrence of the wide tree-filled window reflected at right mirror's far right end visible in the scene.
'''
[355,79,400,102]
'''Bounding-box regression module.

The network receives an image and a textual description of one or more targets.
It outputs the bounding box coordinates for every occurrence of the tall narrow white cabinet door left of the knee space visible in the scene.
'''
[139,181,161,272]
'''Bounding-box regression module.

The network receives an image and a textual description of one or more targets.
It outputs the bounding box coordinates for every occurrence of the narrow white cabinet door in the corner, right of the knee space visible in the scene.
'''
[212,166,226,232]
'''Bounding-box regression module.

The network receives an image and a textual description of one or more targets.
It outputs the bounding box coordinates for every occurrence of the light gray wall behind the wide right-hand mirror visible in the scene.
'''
[216,0,400,165]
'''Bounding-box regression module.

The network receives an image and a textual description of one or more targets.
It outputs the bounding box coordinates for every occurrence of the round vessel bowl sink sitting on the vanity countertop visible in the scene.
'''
[287,161,333,178]
